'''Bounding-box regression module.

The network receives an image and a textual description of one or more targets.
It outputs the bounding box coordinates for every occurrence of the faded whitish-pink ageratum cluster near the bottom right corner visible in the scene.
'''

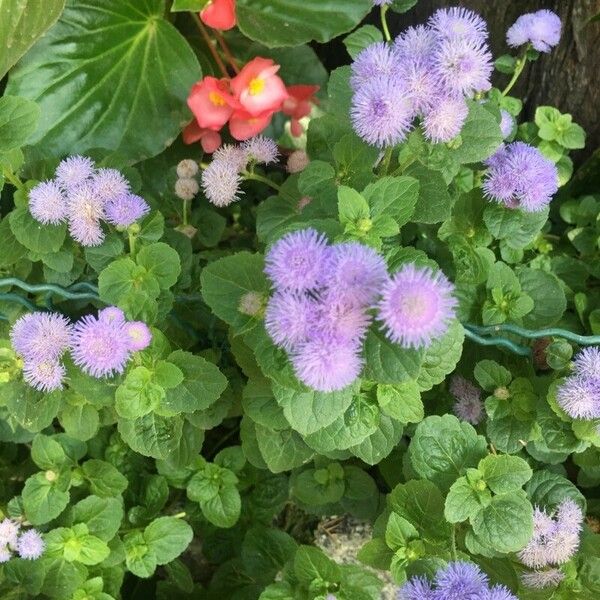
[519,498,583,588]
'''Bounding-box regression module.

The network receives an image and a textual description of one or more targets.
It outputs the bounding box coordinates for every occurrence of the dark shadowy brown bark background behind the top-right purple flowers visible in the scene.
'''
[316,0,600,163]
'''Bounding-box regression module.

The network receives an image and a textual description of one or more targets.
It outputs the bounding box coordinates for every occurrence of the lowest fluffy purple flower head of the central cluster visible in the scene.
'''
[291,337,363,392]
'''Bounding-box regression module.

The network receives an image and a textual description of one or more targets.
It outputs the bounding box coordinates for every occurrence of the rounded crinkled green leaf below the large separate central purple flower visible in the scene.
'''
[408,415,487,490]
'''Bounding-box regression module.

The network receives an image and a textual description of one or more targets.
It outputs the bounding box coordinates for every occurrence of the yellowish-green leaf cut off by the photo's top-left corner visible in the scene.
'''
[0,0,65,79]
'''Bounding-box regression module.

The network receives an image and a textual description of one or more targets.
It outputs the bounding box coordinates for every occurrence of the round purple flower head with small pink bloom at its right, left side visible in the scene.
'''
[71,315,130,378]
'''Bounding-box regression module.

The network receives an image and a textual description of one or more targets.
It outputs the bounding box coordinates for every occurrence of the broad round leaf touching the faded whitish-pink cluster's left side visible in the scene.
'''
[471,492,533,553]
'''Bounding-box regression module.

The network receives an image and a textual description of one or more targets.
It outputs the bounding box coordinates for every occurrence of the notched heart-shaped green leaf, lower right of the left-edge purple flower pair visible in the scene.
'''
[164,350,227,413]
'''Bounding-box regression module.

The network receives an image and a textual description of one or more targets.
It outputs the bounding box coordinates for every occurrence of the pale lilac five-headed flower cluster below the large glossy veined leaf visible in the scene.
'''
[29,156,150,246]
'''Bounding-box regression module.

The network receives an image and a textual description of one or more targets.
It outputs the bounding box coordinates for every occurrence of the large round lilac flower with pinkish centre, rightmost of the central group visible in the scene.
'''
[378,264,457,348]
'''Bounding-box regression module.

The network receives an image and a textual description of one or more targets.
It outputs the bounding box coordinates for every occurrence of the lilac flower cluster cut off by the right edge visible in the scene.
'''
[556,347,600,419]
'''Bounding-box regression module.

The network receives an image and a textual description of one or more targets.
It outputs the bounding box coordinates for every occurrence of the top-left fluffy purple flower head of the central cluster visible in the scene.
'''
[265,228,329,292]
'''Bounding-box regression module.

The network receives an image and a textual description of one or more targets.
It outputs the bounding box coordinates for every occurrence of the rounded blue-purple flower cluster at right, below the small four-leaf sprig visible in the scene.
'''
[483,142,558,212]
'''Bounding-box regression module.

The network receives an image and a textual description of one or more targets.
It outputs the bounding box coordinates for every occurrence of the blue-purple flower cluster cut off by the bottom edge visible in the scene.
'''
[397,561,517,600]
